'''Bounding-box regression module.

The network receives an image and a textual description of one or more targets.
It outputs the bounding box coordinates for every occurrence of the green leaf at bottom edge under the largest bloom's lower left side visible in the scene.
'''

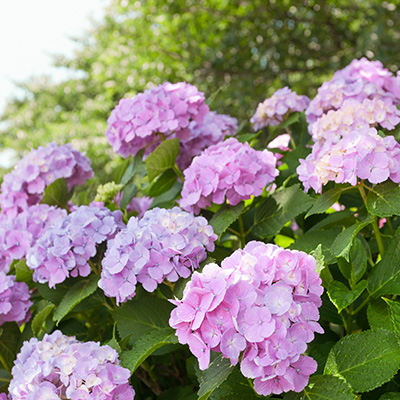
[197,355,233,400]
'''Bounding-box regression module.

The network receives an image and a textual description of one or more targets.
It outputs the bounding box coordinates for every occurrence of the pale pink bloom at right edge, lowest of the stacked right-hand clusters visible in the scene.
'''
[297,127,400,193]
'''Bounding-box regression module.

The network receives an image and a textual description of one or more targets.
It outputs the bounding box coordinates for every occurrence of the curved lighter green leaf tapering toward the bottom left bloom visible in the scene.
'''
[121,328,178,373]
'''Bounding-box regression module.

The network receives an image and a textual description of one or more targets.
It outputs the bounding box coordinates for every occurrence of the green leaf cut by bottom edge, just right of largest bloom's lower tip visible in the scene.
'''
[284,375,356,400]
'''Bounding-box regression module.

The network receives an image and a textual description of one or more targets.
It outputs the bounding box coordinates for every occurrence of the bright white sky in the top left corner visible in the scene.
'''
[0,0,110,113]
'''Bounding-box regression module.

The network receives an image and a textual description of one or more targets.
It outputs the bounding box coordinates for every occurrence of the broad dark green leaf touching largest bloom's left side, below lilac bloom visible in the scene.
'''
[113,297,174,340]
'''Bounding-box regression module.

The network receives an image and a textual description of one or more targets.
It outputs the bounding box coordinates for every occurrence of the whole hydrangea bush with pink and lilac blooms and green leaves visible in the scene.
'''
[0,59,400,400]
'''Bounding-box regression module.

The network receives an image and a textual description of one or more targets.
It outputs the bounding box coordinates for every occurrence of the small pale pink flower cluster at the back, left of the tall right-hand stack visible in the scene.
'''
[250,86,310,131]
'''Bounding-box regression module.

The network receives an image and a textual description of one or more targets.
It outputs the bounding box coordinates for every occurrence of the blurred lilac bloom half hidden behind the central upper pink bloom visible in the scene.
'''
[176,111,238,169]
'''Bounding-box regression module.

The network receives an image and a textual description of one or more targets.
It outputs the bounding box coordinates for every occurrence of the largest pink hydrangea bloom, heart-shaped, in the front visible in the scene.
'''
[169,241,323,396]
